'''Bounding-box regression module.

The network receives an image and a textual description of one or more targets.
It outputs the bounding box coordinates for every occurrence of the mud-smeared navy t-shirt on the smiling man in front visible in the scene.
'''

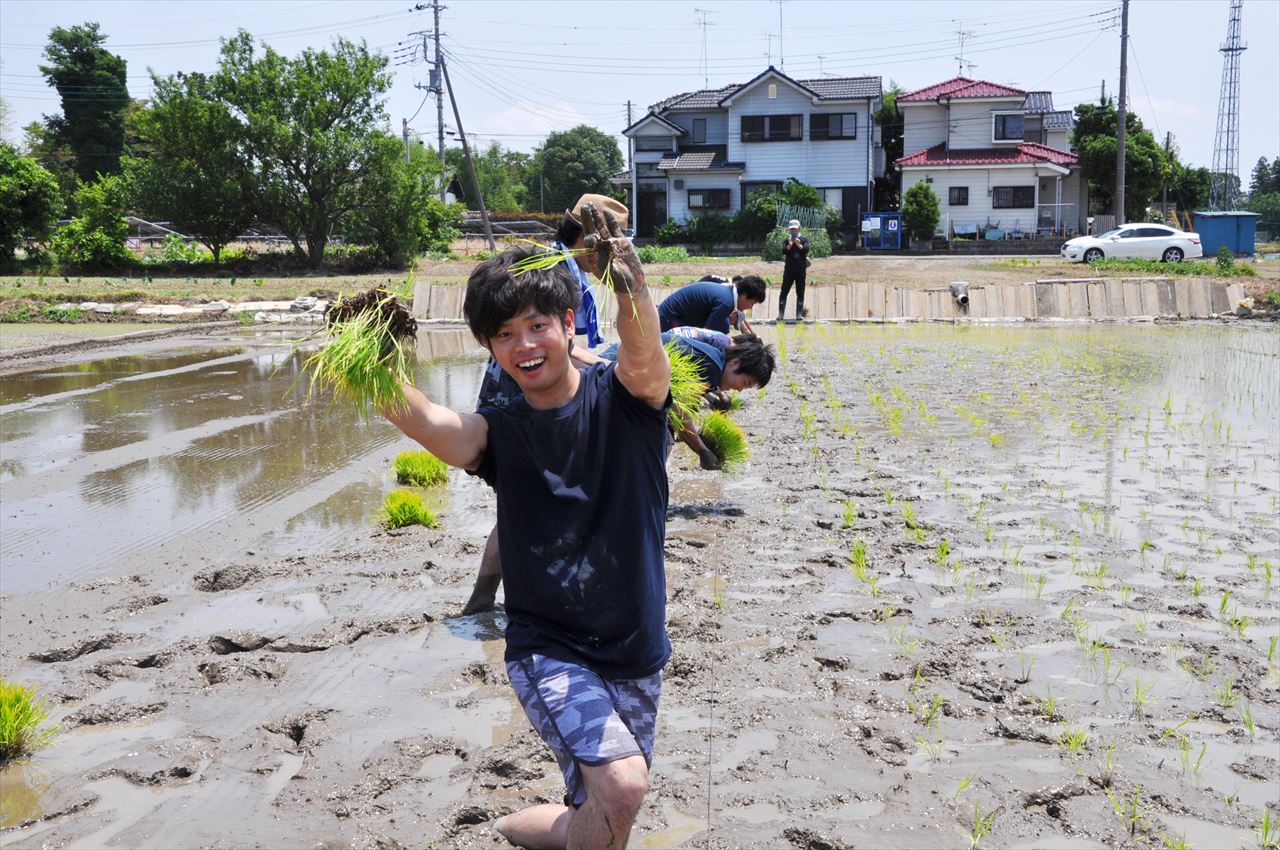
[475,364,671,678]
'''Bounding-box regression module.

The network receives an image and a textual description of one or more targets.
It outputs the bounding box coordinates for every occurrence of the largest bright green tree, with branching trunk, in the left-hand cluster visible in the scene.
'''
[212,31,392,269]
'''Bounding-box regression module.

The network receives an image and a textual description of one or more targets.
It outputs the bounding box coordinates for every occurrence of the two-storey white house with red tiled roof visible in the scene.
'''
[897,77,1088,238]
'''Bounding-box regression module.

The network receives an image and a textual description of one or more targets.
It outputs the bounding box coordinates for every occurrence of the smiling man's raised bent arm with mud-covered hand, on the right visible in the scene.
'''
[582,204,671,407]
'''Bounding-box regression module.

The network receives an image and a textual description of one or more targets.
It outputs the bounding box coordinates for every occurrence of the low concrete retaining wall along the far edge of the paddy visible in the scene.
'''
[413,278,1244,321]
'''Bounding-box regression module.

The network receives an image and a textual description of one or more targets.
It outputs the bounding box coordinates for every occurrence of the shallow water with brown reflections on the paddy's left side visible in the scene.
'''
[0,330,484,593]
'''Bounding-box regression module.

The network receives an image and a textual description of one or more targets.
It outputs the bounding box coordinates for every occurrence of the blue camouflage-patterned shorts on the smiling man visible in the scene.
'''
[507,654,662,806]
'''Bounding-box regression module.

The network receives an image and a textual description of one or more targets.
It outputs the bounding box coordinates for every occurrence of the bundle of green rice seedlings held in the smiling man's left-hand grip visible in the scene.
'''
[306,287,417,416]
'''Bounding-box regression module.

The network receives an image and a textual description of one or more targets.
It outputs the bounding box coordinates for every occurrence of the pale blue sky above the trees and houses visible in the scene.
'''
[0,0,1280,184]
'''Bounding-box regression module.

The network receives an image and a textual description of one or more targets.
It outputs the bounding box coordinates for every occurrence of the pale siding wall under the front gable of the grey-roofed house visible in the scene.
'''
[727,79,874,187]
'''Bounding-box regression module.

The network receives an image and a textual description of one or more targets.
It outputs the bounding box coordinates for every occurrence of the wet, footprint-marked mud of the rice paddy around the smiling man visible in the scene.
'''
[0,324,1280,850]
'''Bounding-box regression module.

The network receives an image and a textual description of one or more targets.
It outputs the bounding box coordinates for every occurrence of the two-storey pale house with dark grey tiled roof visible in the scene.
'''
[614,65,884,237]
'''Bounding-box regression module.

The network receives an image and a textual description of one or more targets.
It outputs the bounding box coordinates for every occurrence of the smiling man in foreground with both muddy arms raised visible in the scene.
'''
[383,205,671,849]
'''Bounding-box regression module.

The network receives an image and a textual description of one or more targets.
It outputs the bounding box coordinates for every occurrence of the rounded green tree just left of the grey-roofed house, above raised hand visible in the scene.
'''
[526,124,623,218]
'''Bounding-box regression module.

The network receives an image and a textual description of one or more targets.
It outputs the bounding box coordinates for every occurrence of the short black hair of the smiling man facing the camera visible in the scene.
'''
[462,246,580,344]
